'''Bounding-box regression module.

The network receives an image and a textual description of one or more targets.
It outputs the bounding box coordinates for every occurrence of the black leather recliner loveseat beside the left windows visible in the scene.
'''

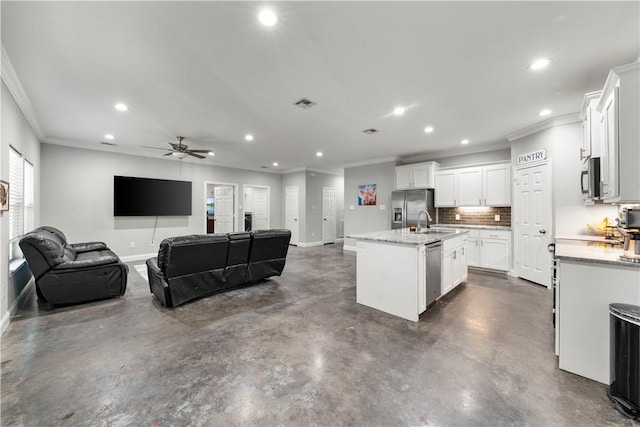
[19,226,129,305]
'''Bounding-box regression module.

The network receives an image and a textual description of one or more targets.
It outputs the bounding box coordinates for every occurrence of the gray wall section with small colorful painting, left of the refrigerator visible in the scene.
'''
[344,162,395,247]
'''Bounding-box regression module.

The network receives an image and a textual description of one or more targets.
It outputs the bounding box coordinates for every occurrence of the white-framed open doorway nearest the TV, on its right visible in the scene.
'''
[205,182,238,234]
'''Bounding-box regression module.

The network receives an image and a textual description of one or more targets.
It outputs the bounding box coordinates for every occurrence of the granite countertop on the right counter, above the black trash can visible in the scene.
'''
[556,239,640,269]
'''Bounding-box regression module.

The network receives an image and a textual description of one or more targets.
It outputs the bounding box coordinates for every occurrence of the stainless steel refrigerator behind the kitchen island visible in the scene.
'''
[391,188,436,229]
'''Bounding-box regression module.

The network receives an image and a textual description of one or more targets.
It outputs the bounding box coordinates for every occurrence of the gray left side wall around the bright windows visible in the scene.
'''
[0,81,40,331]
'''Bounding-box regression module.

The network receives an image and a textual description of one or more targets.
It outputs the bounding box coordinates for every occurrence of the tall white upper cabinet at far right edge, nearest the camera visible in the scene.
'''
[597,62,640,203]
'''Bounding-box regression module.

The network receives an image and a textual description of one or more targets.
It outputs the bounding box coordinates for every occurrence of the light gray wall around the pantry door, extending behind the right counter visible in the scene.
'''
[511,122,617,235]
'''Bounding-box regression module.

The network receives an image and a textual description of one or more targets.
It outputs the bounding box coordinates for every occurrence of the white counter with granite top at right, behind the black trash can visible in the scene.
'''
[555,238,640,385]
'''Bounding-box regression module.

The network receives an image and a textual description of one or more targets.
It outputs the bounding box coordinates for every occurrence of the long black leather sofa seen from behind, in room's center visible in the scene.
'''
[147,230,291,307]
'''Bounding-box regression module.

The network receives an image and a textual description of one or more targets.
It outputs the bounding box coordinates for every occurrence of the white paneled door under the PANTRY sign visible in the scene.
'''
[514,164,552,287]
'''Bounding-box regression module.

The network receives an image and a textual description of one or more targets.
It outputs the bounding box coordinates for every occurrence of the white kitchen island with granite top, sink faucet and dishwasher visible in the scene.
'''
[347,228,467,322]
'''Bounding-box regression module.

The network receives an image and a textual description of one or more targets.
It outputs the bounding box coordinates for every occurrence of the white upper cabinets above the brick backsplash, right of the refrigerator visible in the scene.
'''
[435,163,511,207]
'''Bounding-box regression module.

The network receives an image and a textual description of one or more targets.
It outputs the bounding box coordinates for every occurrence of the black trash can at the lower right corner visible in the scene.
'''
[608,304,640,418]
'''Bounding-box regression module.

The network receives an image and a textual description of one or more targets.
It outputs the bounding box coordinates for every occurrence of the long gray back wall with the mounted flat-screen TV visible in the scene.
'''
[41,144,282,259]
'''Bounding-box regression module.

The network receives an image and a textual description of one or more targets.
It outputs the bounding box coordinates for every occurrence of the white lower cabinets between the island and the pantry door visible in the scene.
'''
[467,229,511,271]
